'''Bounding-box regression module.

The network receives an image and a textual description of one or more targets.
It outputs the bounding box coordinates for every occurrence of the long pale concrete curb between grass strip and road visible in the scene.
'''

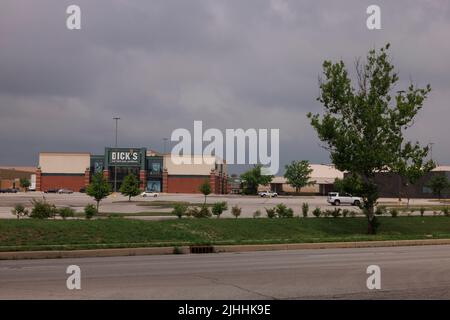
[0,239,450,260]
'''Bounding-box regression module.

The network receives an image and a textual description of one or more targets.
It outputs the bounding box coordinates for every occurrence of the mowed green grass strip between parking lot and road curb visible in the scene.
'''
[0,216,450,251]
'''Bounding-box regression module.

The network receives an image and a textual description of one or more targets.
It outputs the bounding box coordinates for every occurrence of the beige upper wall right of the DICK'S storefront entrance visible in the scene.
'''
[164,154,226,176]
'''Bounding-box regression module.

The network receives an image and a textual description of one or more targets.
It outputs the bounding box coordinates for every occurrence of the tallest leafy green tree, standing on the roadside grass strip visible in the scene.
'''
[308,44,431,234]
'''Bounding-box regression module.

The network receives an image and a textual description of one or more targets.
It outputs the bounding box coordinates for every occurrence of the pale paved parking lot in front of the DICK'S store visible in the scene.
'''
[0,192,440,219]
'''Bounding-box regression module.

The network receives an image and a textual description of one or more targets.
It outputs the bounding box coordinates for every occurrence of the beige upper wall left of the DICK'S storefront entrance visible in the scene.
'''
[39,152,91,173]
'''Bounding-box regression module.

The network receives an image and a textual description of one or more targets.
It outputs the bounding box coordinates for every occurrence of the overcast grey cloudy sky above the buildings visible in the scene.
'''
[0,0,450,175]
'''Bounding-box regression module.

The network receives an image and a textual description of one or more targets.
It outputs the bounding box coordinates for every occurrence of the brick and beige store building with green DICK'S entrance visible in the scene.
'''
[36,148,228,194]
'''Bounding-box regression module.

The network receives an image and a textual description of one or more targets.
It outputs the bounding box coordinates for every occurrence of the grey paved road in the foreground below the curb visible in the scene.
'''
[0,246,450,299]
